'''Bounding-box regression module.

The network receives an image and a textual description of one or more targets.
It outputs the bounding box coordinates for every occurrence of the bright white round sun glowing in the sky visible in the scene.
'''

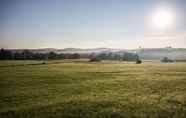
[152,9,174,29]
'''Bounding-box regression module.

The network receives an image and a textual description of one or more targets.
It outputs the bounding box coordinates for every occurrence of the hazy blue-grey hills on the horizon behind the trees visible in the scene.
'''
[5,47,186,59]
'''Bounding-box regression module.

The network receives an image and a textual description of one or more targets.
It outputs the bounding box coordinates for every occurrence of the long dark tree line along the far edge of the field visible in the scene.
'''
[0,49,139,61]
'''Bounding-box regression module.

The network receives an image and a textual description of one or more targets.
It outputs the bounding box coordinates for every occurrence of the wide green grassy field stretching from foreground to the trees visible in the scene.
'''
[0,61,186,118]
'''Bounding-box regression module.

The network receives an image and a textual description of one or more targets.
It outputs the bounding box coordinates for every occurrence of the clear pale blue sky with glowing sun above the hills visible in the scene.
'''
[0,0,186,49]
